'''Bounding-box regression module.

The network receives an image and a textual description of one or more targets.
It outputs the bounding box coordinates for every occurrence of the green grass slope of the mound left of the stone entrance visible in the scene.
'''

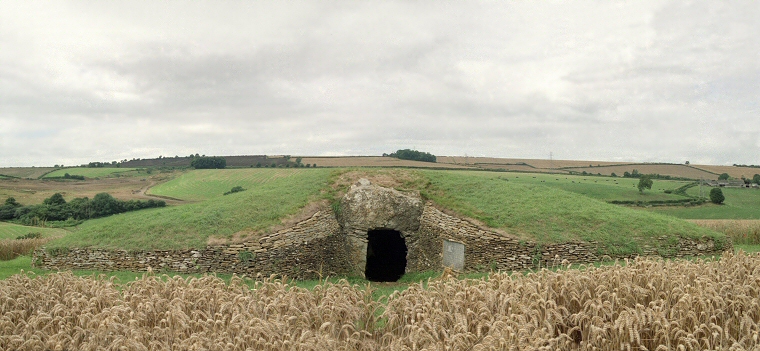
[48,169,331,250]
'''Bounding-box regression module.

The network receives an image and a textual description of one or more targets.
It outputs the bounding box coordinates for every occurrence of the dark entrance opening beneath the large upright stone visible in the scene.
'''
[364,229,407,282]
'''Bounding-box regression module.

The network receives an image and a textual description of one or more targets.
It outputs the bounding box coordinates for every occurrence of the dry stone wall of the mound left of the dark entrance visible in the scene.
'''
[33,211,351,279]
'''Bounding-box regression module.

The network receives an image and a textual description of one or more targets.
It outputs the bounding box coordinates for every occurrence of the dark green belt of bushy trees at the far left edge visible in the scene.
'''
[0,193,166,225]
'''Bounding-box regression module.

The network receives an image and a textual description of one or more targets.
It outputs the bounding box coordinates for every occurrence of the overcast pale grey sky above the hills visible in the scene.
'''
[0,0,760,167]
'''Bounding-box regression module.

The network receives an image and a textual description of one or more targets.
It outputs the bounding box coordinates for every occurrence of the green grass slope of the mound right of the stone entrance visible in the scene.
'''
[421,171,724,254]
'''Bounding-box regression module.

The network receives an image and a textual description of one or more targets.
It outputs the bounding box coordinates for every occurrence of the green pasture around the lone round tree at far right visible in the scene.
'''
[650,186,760,219]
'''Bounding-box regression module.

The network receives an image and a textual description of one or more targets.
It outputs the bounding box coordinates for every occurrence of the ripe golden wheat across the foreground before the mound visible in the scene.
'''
[0,252,760,350]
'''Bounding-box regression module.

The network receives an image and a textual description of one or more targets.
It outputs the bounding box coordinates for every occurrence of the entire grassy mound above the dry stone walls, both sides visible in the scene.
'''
[48,169,725,254]
